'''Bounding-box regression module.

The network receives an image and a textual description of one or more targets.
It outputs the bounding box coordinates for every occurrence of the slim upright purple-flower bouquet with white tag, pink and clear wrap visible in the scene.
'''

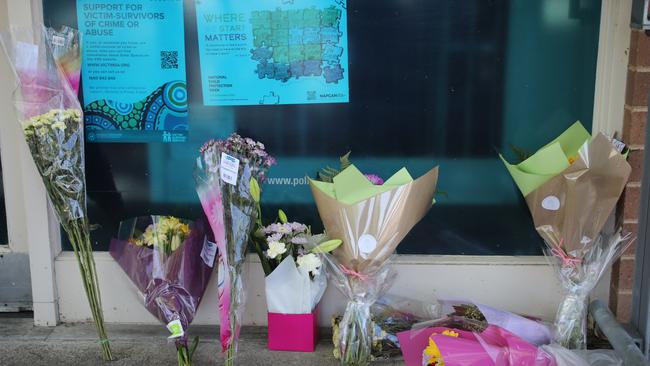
[195,134,275,365]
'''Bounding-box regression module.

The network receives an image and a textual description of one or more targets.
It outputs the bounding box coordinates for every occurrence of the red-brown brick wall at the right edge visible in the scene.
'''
[609,29,650,322]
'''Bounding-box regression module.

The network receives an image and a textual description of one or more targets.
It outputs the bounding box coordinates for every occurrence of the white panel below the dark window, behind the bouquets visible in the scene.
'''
[56,252,609,326]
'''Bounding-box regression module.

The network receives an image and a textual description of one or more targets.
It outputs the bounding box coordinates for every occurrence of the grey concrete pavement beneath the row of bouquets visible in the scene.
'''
[0,317,402,366]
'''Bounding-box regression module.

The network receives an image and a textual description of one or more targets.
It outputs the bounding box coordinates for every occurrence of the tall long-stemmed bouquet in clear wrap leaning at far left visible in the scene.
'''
[0,29,113,360]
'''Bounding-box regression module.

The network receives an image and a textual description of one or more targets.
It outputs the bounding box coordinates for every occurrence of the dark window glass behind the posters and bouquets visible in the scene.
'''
[44,0,601,255]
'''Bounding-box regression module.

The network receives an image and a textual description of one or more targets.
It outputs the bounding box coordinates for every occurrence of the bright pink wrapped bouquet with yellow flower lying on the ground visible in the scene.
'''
[397,317,557,366]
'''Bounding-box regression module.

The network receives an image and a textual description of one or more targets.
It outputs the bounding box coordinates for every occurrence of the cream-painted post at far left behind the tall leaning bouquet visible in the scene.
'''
[0,0,60,325]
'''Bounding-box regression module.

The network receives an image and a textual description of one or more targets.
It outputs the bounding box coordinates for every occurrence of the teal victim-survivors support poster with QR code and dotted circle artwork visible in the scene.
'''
[77,0,188,142]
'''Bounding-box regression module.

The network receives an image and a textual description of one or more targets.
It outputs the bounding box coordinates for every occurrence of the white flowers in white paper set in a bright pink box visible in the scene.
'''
[256,210,341,352]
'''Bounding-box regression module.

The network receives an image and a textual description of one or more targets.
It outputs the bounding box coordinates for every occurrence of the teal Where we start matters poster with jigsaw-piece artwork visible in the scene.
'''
[196,0,349,106]
